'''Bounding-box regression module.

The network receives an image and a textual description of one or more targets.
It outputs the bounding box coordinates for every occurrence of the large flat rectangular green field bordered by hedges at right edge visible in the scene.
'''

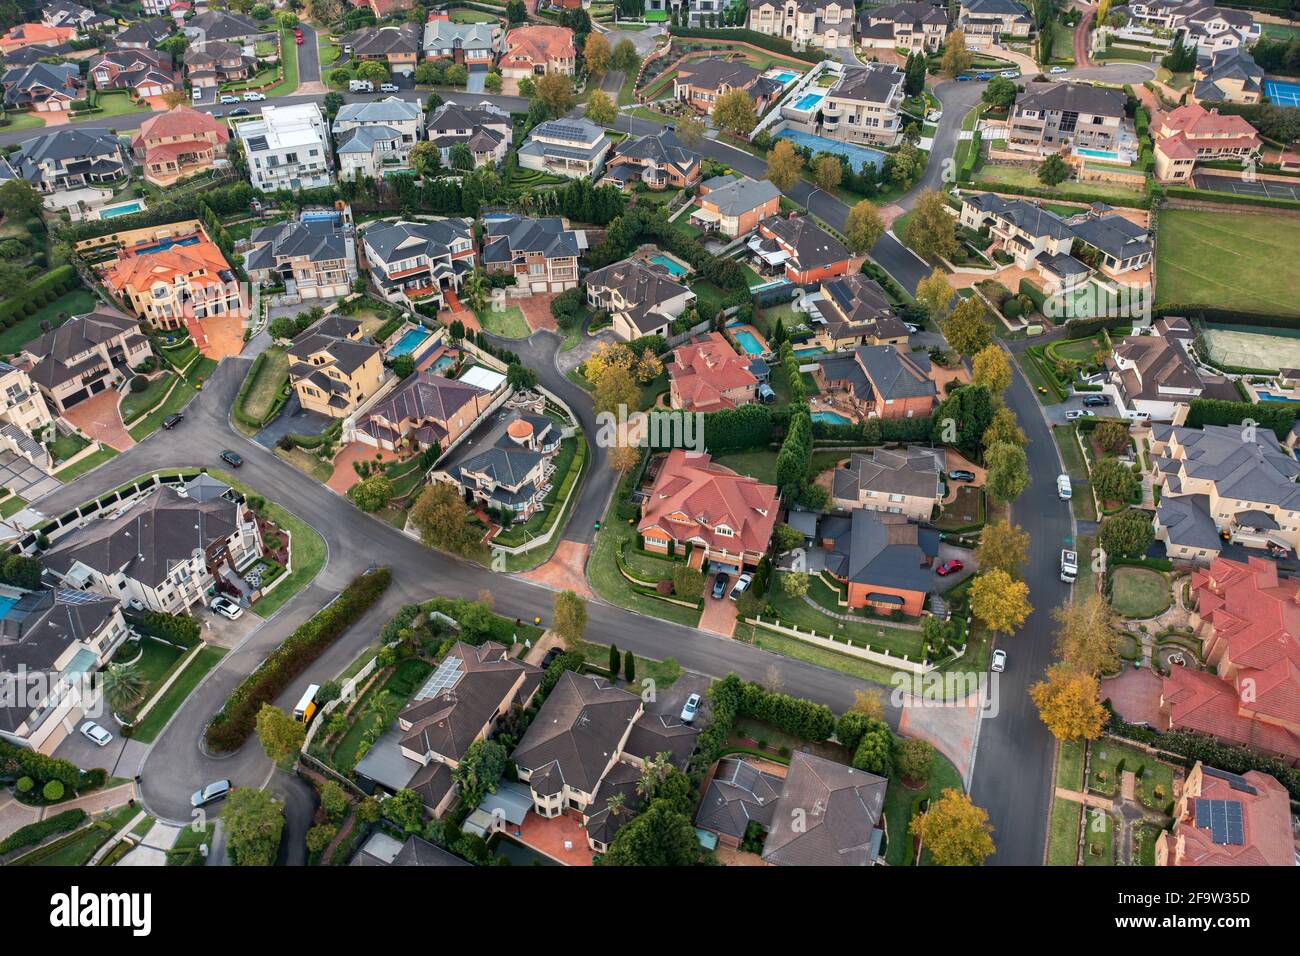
[1156,209,1300,315]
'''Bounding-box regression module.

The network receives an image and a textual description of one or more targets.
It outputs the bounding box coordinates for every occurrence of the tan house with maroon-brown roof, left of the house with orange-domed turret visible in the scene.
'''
[356,369,498,451]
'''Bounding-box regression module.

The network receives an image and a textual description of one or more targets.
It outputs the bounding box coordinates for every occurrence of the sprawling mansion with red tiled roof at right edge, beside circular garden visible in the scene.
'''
[1160,558,1300,766]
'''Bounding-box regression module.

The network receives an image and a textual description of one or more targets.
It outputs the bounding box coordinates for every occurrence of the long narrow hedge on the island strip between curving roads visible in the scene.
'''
[204,567,393,752]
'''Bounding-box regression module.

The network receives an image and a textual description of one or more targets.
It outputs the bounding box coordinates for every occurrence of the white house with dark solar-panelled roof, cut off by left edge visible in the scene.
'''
[0,587,130,754]
